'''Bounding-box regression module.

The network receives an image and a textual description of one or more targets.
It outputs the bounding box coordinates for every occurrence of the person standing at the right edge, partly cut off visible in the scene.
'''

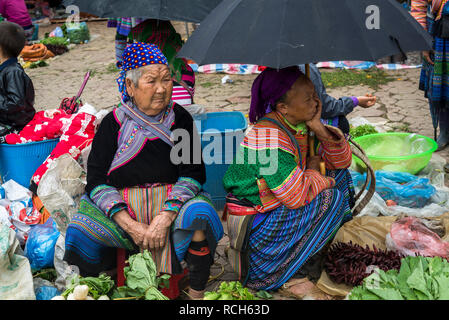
[411,0,449,151]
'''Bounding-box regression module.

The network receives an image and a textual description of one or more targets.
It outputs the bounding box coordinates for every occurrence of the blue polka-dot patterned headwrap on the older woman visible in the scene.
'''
[117,42,168,102]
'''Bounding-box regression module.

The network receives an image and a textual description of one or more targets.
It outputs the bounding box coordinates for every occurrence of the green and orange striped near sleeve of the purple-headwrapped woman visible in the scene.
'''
[263,150,335,209]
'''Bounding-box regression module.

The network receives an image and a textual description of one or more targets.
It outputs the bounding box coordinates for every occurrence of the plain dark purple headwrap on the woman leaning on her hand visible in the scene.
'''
[249,66,303,123]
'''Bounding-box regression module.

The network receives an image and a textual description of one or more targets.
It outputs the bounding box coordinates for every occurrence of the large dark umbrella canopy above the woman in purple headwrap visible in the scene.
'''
[178,0,432,68]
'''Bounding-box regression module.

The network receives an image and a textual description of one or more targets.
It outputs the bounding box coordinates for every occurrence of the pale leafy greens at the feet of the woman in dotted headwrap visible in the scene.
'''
[112,250,170,300]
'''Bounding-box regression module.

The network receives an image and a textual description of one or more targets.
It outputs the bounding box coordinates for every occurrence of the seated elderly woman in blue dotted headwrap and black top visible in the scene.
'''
[64,43,223,298]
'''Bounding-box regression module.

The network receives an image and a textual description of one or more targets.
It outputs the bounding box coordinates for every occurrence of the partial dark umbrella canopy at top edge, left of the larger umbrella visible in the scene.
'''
[63,0,221,22]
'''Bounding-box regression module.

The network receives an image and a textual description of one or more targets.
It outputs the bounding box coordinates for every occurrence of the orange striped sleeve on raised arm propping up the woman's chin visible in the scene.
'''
[318,125,352,170]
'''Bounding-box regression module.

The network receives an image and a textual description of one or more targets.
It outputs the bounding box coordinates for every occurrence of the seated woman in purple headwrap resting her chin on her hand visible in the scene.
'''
[223,67,354,292]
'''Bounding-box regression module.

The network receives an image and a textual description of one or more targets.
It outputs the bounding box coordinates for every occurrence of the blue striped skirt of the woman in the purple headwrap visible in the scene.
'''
[245,170,354,290]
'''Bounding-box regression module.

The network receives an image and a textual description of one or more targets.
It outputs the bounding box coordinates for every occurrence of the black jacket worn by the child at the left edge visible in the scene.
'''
[0,58,36,131]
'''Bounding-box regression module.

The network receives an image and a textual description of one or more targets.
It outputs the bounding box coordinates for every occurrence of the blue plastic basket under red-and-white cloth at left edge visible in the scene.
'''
[0,139,59,188]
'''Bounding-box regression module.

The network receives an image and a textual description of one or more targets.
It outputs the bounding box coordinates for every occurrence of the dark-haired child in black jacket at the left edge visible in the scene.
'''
[0,21,36,139]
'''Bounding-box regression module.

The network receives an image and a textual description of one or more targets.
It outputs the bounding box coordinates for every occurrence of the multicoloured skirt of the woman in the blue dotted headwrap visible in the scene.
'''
[64,185,223,276]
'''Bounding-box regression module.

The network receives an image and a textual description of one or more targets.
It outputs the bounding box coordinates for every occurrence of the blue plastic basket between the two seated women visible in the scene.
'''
[193,111,248,210]
